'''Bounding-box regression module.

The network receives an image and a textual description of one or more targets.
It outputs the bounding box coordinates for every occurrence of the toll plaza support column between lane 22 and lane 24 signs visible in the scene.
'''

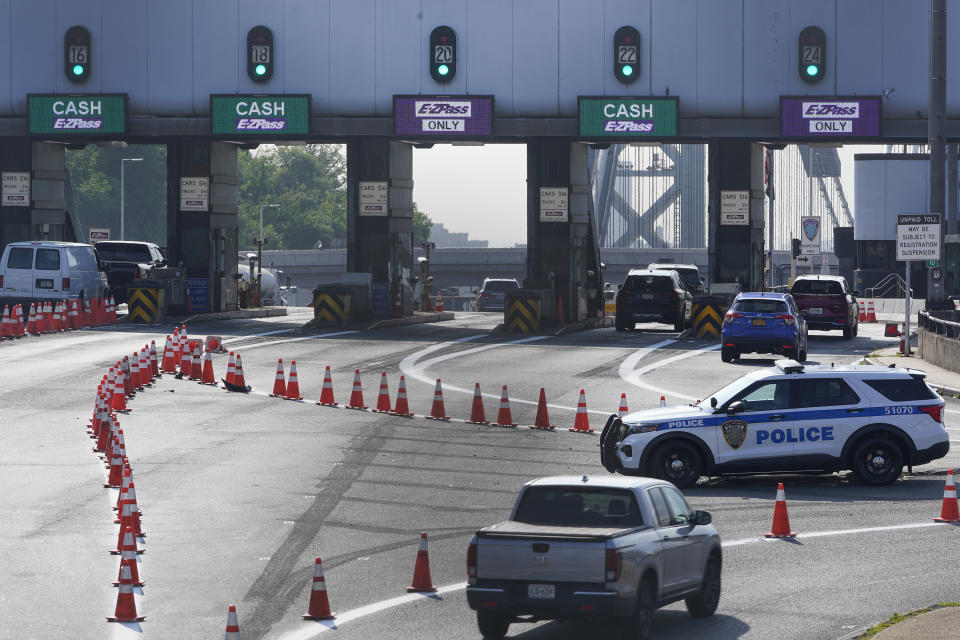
[707,140,764,291]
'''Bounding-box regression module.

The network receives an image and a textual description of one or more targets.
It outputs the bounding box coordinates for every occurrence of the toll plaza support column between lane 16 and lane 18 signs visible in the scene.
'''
[167,139,239,312]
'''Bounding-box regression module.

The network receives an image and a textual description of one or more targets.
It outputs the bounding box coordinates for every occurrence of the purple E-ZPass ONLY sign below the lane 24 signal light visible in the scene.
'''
[780,96,881,139]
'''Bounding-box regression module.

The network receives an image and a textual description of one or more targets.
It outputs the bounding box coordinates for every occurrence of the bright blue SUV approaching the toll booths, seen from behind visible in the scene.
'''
[720,293,807,362]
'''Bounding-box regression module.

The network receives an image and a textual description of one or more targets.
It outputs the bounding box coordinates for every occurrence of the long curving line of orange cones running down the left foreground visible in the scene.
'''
[87,341,160,622]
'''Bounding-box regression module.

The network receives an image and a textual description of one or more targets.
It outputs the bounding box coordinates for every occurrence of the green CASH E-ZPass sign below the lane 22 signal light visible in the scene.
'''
[577,96,677,138]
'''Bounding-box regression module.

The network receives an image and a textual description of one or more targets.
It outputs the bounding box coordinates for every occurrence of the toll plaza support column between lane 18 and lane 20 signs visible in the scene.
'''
[347,138,413,315]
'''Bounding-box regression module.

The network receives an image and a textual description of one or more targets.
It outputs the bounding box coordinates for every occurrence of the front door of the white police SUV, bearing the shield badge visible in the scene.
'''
[716,378,796,470]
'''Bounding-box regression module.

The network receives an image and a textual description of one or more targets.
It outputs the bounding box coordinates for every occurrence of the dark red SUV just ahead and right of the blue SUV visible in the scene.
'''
[790,275,860,339]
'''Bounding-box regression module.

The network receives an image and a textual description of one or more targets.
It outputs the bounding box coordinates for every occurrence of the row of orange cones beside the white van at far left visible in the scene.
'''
[0,296,117,339]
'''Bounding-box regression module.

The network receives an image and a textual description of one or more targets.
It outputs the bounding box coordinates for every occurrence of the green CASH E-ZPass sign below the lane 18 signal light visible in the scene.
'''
[210,94,310,138]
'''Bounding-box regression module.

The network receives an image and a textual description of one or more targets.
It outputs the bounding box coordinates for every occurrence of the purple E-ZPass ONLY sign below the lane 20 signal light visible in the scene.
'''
[393,95,493,138]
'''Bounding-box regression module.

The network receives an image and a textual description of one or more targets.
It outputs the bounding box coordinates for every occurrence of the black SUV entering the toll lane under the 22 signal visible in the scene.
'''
[614,269,693,331]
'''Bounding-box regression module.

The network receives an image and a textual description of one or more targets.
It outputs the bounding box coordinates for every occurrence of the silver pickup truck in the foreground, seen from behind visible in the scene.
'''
[467,476,721,639]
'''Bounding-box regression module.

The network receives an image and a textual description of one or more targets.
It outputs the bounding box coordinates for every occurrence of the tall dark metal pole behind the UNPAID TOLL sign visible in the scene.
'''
[927,0,947,309]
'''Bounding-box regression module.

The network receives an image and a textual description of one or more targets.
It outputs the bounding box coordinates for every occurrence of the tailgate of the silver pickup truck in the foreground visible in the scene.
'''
[477,521,624,582]
